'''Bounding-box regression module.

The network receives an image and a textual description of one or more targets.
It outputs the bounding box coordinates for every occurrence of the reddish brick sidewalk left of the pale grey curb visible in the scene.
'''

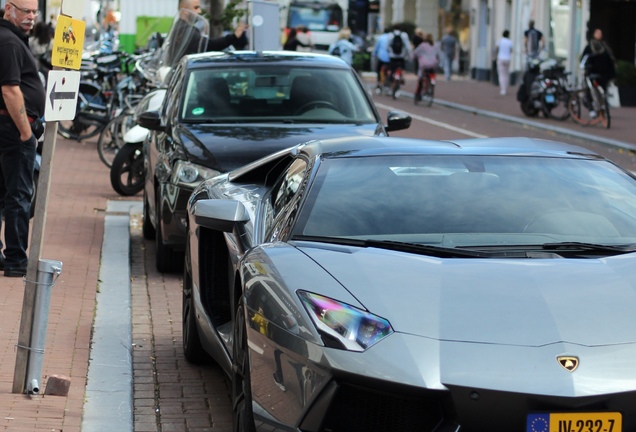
[0,137,125,432]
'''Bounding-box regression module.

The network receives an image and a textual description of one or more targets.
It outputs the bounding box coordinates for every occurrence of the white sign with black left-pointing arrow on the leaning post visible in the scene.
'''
[44,70,80,122]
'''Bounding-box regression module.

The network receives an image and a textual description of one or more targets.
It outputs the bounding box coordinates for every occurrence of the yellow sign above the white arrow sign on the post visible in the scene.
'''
[51,15,86,70]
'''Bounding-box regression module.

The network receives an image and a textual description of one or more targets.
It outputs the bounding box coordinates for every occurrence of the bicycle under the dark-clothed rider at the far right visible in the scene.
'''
[568,74,611,129]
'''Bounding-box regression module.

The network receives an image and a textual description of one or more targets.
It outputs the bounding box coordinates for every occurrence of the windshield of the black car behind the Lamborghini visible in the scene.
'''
[180,65,377,124]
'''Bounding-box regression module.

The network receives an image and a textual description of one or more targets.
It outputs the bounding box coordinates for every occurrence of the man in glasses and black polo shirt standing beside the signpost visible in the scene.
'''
[0,0,46,277]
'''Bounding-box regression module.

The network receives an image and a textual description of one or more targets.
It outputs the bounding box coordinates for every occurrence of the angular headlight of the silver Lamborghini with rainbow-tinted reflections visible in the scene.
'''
[298,291,393,351]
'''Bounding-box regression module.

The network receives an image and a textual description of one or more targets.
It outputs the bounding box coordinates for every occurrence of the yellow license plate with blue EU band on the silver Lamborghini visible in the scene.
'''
[526,412,623,432]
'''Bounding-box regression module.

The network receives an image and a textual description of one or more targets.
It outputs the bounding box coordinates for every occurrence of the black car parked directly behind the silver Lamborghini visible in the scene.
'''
[138,51,411,272]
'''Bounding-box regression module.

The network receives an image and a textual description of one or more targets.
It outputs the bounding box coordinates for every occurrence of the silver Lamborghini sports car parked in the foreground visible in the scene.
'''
[183,137,636,432]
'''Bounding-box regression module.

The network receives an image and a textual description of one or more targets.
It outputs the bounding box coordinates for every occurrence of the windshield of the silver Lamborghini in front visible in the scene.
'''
[294,156,636,246]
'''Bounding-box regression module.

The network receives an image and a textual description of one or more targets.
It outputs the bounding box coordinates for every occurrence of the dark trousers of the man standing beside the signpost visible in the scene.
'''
[0,116,37,267]
